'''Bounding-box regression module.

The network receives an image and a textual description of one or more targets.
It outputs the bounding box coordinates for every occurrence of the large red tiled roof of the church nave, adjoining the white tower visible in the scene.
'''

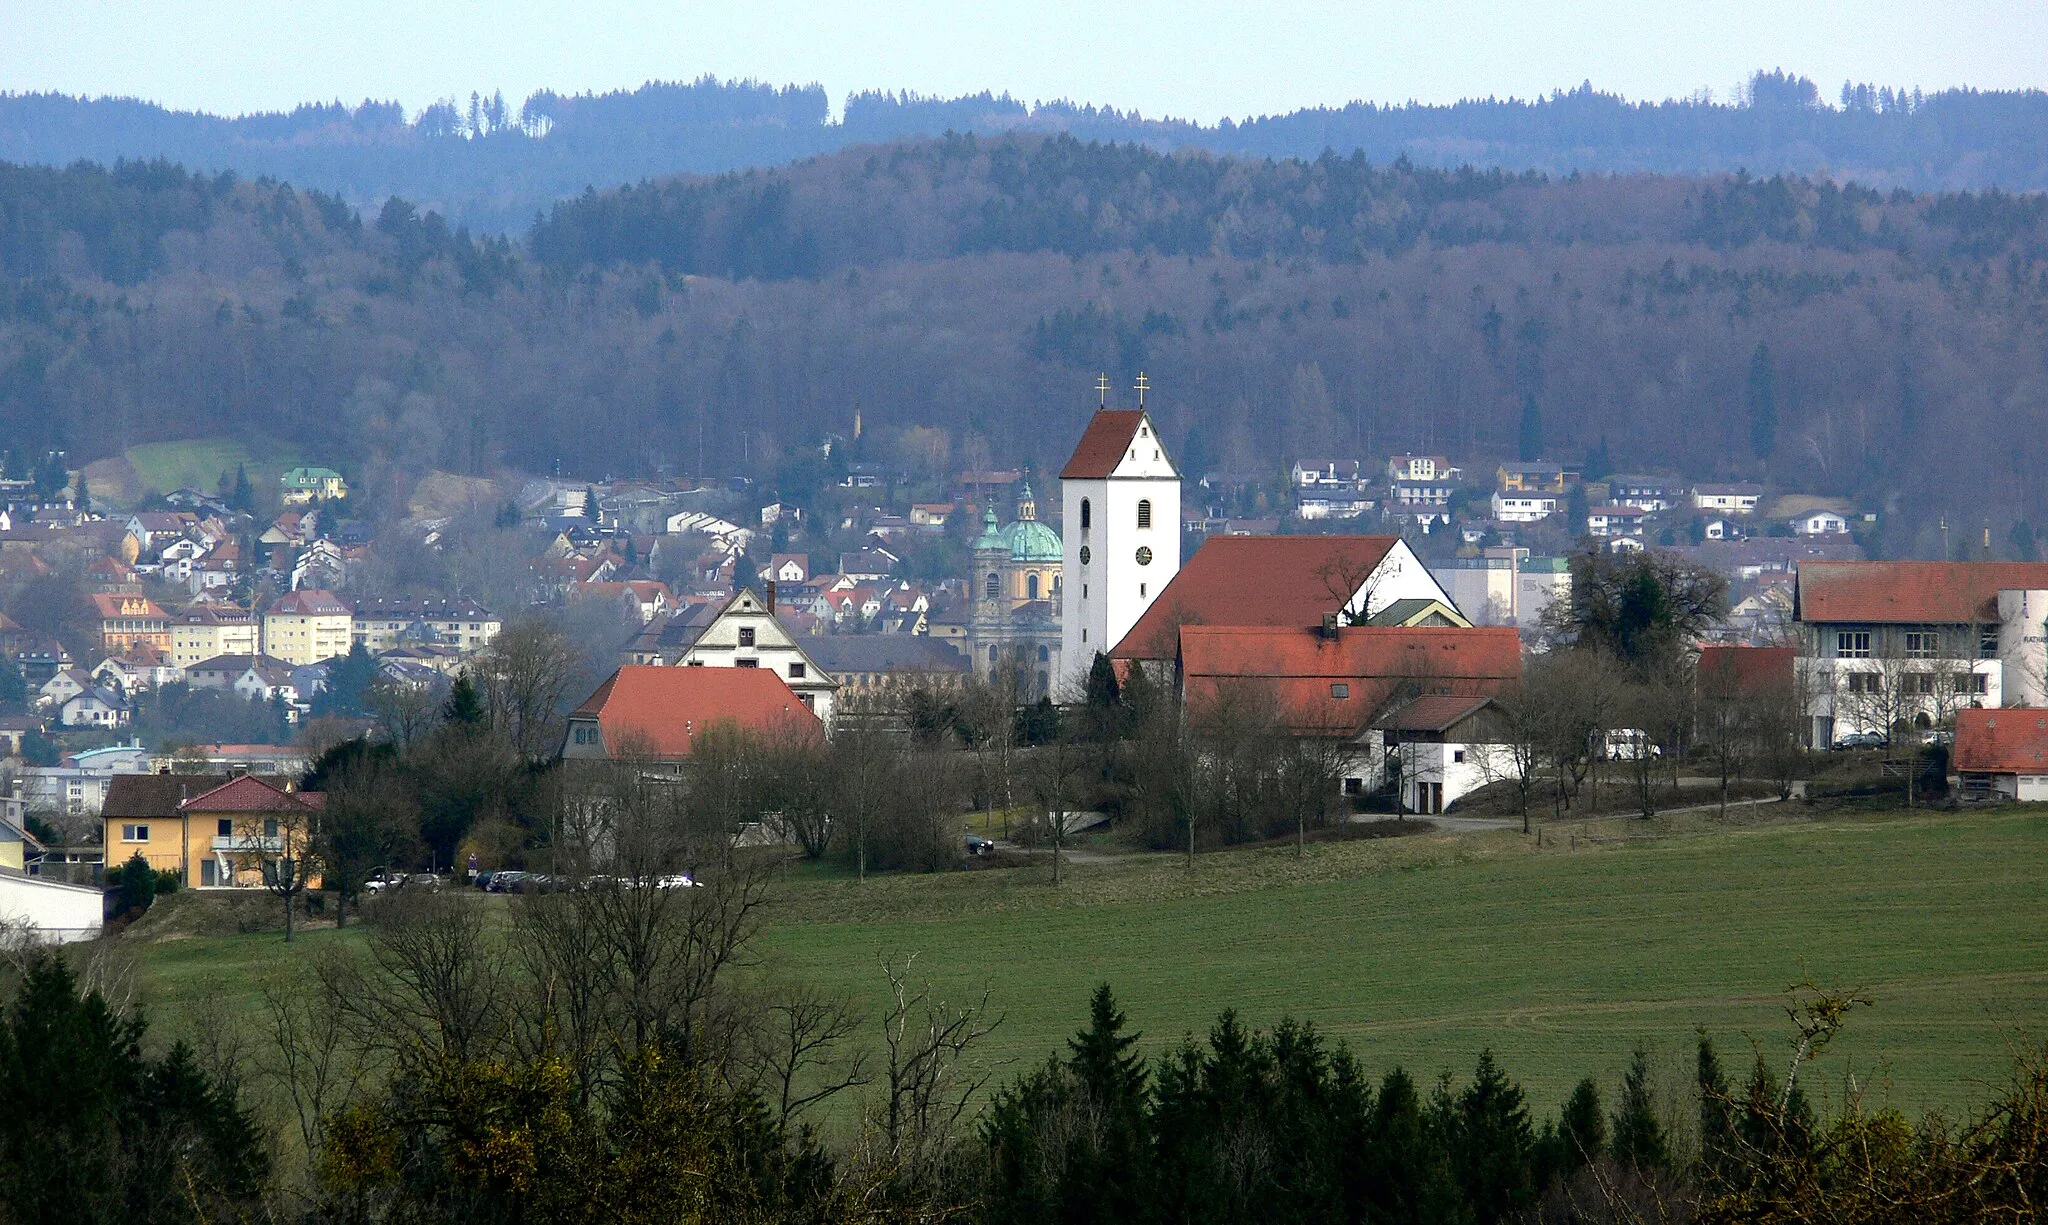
[1110,537,1401,660]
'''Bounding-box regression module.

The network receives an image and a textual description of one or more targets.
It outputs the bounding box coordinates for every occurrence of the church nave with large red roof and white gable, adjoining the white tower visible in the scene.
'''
[1114,537,1456,670]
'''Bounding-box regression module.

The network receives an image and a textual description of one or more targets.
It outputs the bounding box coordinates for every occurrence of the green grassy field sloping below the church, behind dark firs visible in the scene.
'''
[123,809,2048,1112]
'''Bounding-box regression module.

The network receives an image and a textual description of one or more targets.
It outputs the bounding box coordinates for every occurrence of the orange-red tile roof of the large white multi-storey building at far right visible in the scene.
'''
[1792,561,2048,625]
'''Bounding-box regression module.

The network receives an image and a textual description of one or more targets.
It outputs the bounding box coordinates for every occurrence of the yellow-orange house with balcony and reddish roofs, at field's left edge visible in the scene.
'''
[102,774,324,889]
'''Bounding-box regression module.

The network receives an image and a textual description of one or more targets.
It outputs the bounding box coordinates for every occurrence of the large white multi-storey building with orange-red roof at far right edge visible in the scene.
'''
[1792,561,2048,746]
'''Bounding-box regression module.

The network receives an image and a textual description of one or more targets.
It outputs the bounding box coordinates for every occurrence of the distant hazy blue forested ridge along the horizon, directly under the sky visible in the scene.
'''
[12,72,2048,231]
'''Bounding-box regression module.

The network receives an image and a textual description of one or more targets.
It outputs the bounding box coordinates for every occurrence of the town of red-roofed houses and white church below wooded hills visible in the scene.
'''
[0,379,2048,913]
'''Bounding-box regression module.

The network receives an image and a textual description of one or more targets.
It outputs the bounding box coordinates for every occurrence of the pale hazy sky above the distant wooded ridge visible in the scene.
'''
[0,0,2048,121]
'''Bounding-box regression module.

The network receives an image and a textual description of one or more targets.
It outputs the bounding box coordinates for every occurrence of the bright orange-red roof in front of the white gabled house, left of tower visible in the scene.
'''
[561,664,825,766]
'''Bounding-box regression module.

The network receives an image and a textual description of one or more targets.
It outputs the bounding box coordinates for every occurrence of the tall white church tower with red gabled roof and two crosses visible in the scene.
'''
[1059,375,1180,686]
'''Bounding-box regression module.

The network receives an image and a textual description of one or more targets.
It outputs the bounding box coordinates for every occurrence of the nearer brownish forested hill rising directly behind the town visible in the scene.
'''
[0,135,2048,553]
